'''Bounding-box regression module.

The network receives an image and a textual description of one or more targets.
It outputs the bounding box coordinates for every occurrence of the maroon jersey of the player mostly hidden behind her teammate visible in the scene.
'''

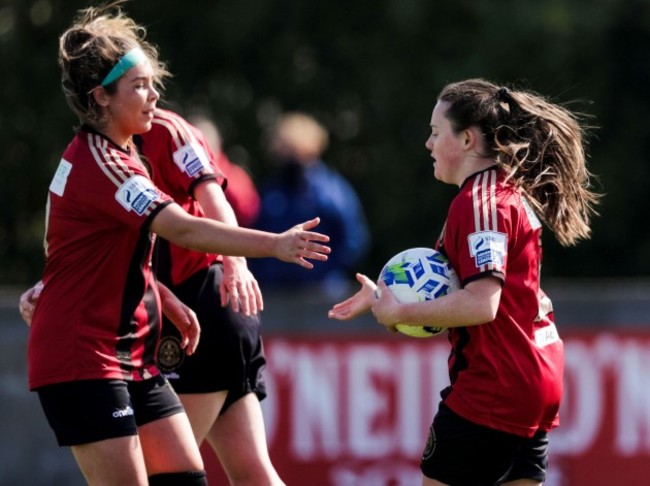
[138,109,225,286]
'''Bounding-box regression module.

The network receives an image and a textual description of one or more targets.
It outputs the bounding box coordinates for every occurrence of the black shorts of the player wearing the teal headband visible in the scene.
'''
[36,376,184,446]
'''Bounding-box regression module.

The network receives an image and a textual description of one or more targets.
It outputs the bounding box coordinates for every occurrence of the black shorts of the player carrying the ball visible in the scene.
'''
[420,403,548,486]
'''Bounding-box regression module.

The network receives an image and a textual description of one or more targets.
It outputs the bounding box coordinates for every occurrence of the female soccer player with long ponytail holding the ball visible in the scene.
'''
[329,79,599,486]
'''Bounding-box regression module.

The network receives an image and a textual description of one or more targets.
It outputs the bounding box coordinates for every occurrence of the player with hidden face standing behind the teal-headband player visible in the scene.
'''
[135,109,284,486]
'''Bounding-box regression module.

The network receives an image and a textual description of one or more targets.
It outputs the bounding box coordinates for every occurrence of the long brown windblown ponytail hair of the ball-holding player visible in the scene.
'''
[438,79,601,246]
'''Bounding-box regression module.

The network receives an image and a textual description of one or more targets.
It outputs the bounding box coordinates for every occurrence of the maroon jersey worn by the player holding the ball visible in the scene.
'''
[438,168,564,437]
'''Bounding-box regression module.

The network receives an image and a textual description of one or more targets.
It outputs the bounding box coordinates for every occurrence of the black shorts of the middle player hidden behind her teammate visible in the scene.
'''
[158,263,266,413]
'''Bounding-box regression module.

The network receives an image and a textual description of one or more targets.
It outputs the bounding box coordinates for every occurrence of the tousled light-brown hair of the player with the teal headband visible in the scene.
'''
[59,0,170,128]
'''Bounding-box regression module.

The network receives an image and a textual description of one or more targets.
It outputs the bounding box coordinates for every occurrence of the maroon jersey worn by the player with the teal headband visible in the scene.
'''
[28,128,171,389]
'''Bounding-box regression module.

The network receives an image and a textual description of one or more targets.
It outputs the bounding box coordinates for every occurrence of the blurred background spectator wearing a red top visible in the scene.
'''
[189,115,260,227]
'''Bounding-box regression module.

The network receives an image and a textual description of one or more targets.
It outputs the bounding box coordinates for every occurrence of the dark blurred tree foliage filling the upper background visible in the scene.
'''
[0,0,650,284]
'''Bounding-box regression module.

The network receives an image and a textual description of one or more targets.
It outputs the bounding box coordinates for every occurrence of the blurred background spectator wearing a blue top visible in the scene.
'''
[249,113,370,293]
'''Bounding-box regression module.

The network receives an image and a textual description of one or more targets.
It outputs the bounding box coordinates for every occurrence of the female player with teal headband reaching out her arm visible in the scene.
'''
[28,2,329,486]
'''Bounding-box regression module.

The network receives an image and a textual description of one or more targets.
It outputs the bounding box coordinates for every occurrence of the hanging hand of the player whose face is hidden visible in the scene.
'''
[219,256,264,316]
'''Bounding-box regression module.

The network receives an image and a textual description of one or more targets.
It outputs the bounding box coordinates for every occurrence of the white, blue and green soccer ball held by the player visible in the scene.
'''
[379,248,460,337]
